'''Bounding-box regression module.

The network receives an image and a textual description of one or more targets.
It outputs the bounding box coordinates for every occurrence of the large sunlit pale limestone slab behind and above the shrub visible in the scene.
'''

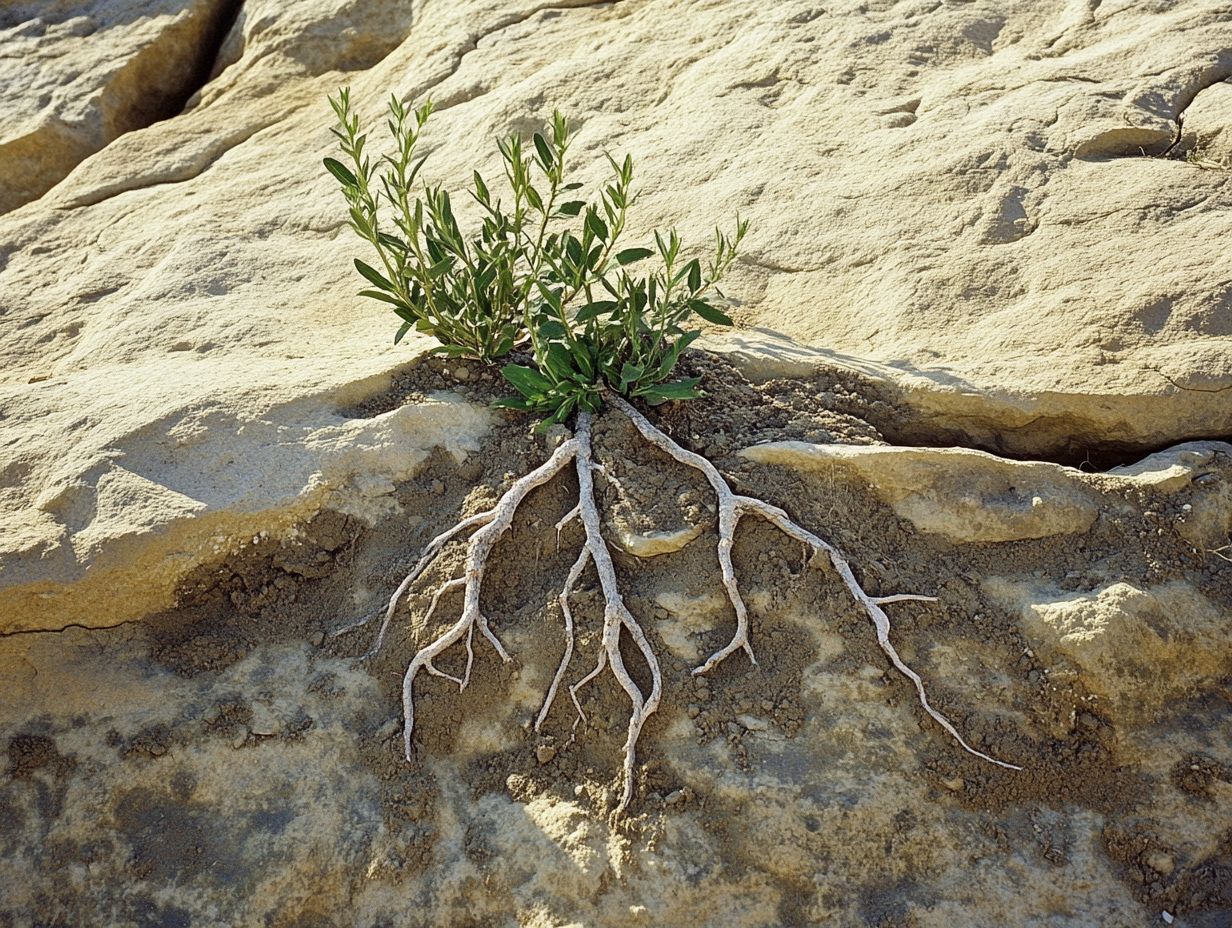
[0,0,1232,630]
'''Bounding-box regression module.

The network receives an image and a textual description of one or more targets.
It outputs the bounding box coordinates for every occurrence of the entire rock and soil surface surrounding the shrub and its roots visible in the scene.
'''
[0,0,1232,928]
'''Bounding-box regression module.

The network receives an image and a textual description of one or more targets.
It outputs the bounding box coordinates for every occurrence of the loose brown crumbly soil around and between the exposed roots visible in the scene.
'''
[9,354,1232,924]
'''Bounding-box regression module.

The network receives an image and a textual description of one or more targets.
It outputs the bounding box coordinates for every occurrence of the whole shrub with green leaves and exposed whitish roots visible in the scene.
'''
[325,90,1021,816]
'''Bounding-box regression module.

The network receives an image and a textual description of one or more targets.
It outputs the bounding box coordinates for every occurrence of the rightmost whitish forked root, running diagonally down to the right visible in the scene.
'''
[607,393,1023,770]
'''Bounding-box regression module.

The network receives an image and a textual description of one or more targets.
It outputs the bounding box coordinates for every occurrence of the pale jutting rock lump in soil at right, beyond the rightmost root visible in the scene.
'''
[984,578,1232,725]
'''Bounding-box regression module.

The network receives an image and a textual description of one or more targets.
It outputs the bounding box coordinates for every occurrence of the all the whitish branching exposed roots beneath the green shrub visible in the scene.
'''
[372,394,1021,816]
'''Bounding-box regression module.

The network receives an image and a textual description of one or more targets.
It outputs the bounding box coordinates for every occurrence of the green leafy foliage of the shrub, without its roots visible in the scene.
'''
[325,89,748,423]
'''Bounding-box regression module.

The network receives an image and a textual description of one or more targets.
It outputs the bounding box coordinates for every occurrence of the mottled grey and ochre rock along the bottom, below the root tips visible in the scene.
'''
[0,611,1148,928]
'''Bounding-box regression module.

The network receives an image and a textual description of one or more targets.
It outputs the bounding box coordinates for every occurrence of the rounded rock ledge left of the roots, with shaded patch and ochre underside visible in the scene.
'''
[0,394,490,631]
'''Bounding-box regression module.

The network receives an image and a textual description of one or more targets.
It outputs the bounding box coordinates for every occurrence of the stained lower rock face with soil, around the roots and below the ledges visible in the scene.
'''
[0,421,1232,928]
